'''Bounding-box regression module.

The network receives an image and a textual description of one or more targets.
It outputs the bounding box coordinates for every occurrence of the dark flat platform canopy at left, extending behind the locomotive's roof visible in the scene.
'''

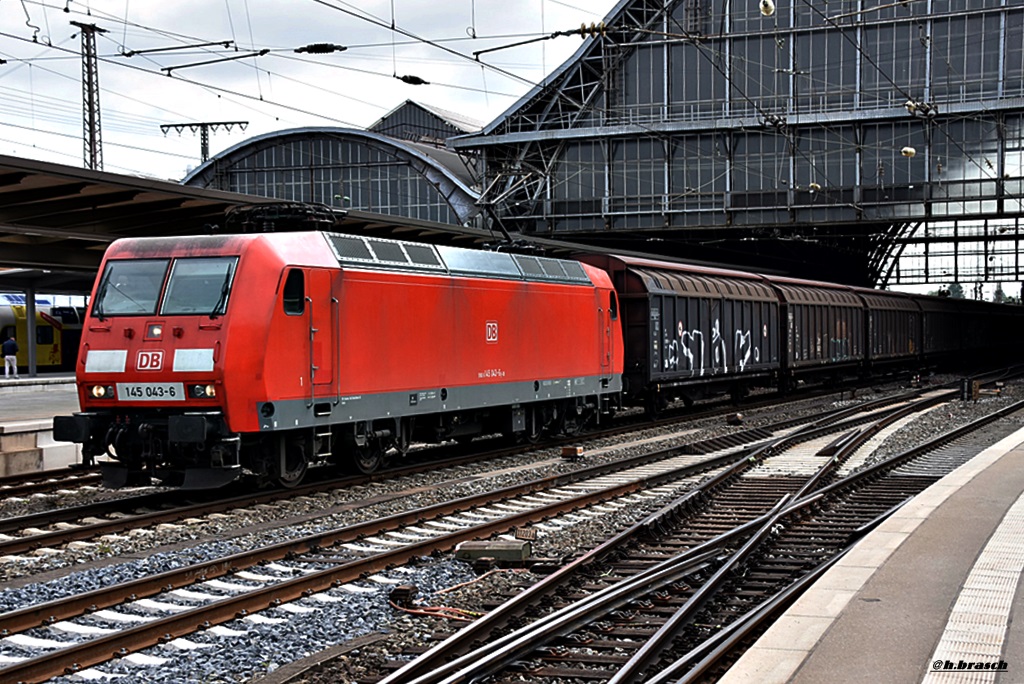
[0,156,528,294]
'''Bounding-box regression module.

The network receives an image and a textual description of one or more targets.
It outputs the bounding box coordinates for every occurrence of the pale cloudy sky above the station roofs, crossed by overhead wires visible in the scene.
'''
[0,0,616,181]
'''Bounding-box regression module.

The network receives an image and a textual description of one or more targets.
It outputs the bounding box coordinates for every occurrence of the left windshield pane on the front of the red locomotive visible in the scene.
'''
[92,259,169,318]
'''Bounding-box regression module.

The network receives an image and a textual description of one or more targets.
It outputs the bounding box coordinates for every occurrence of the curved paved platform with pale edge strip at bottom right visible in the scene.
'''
[719,429,1024,684]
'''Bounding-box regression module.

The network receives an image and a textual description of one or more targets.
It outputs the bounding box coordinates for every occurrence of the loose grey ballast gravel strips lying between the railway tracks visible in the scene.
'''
[0,376,1024,684]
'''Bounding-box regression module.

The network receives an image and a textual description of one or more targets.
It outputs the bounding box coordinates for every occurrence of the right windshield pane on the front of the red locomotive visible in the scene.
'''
[160,257,238,317]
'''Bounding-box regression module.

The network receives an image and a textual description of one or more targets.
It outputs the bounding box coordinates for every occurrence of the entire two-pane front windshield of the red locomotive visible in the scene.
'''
[92,257,238,318]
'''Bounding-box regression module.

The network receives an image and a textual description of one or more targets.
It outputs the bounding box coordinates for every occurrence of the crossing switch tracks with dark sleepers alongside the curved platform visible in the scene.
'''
[374,389,1024,684]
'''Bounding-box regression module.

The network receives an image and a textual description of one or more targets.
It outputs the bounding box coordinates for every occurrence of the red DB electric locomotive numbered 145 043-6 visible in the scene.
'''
[54,231,623,488]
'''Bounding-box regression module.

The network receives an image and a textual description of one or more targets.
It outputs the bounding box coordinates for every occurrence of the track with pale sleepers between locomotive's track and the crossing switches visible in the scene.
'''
[0,389,929,681]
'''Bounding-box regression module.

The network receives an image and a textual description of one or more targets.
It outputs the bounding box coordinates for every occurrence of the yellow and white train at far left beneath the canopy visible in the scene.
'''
[0,294,85,373]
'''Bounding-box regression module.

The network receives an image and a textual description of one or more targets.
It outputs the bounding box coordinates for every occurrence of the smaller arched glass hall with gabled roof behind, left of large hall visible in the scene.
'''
[182,101,479,225]
